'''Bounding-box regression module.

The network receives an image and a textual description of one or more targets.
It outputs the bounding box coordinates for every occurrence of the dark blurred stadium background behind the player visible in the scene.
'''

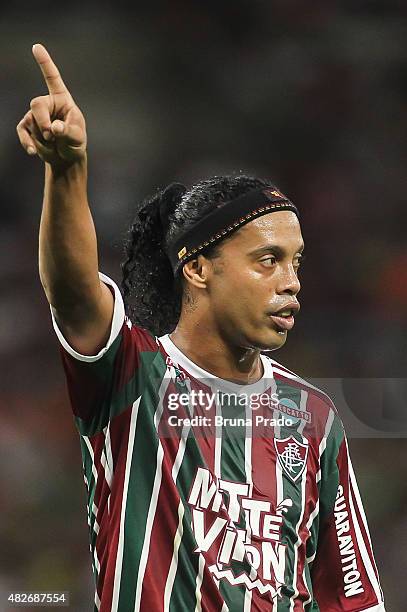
[0,0,407,612]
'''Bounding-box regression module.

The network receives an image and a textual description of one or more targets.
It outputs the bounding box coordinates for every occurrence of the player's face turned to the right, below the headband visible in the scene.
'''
[196,211,304,350]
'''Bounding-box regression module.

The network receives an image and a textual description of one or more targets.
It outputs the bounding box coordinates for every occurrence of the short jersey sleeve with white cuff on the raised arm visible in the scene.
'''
[50,272,158,436]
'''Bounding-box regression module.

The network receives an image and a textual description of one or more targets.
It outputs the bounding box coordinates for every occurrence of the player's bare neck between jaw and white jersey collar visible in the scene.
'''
[169,312,263,384]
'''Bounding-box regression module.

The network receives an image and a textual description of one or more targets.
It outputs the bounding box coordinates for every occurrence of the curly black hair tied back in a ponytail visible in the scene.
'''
[121,174,277,336]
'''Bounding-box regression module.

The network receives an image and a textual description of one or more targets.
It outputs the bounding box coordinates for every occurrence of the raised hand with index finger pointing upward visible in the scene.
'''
[17,44,86,167]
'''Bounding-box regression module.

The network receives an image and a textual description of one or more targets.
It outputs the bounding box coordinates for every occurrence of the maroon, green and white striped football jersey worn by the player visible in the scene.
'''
[51,273,385,612]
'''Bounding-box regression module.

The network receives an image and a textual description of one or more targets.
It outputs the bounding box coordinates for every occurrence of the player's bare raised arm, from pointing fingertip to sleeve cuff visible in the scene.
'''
[17,44,113,355]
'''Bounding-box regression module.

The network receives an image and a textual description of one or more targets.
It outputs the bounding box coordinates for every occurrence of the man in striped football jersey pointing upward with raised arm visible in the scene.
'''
[17,44,384,612]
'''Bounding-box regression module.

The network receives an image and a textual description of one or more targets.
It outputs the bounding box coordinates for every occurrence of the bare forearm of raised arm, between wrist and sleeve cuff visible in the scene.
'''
[39,157,100,314]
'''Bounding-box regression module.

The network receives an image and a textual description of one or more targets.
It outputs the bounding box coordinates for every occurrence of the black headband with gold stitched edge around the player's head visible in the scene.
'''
[168,187,300,276]
